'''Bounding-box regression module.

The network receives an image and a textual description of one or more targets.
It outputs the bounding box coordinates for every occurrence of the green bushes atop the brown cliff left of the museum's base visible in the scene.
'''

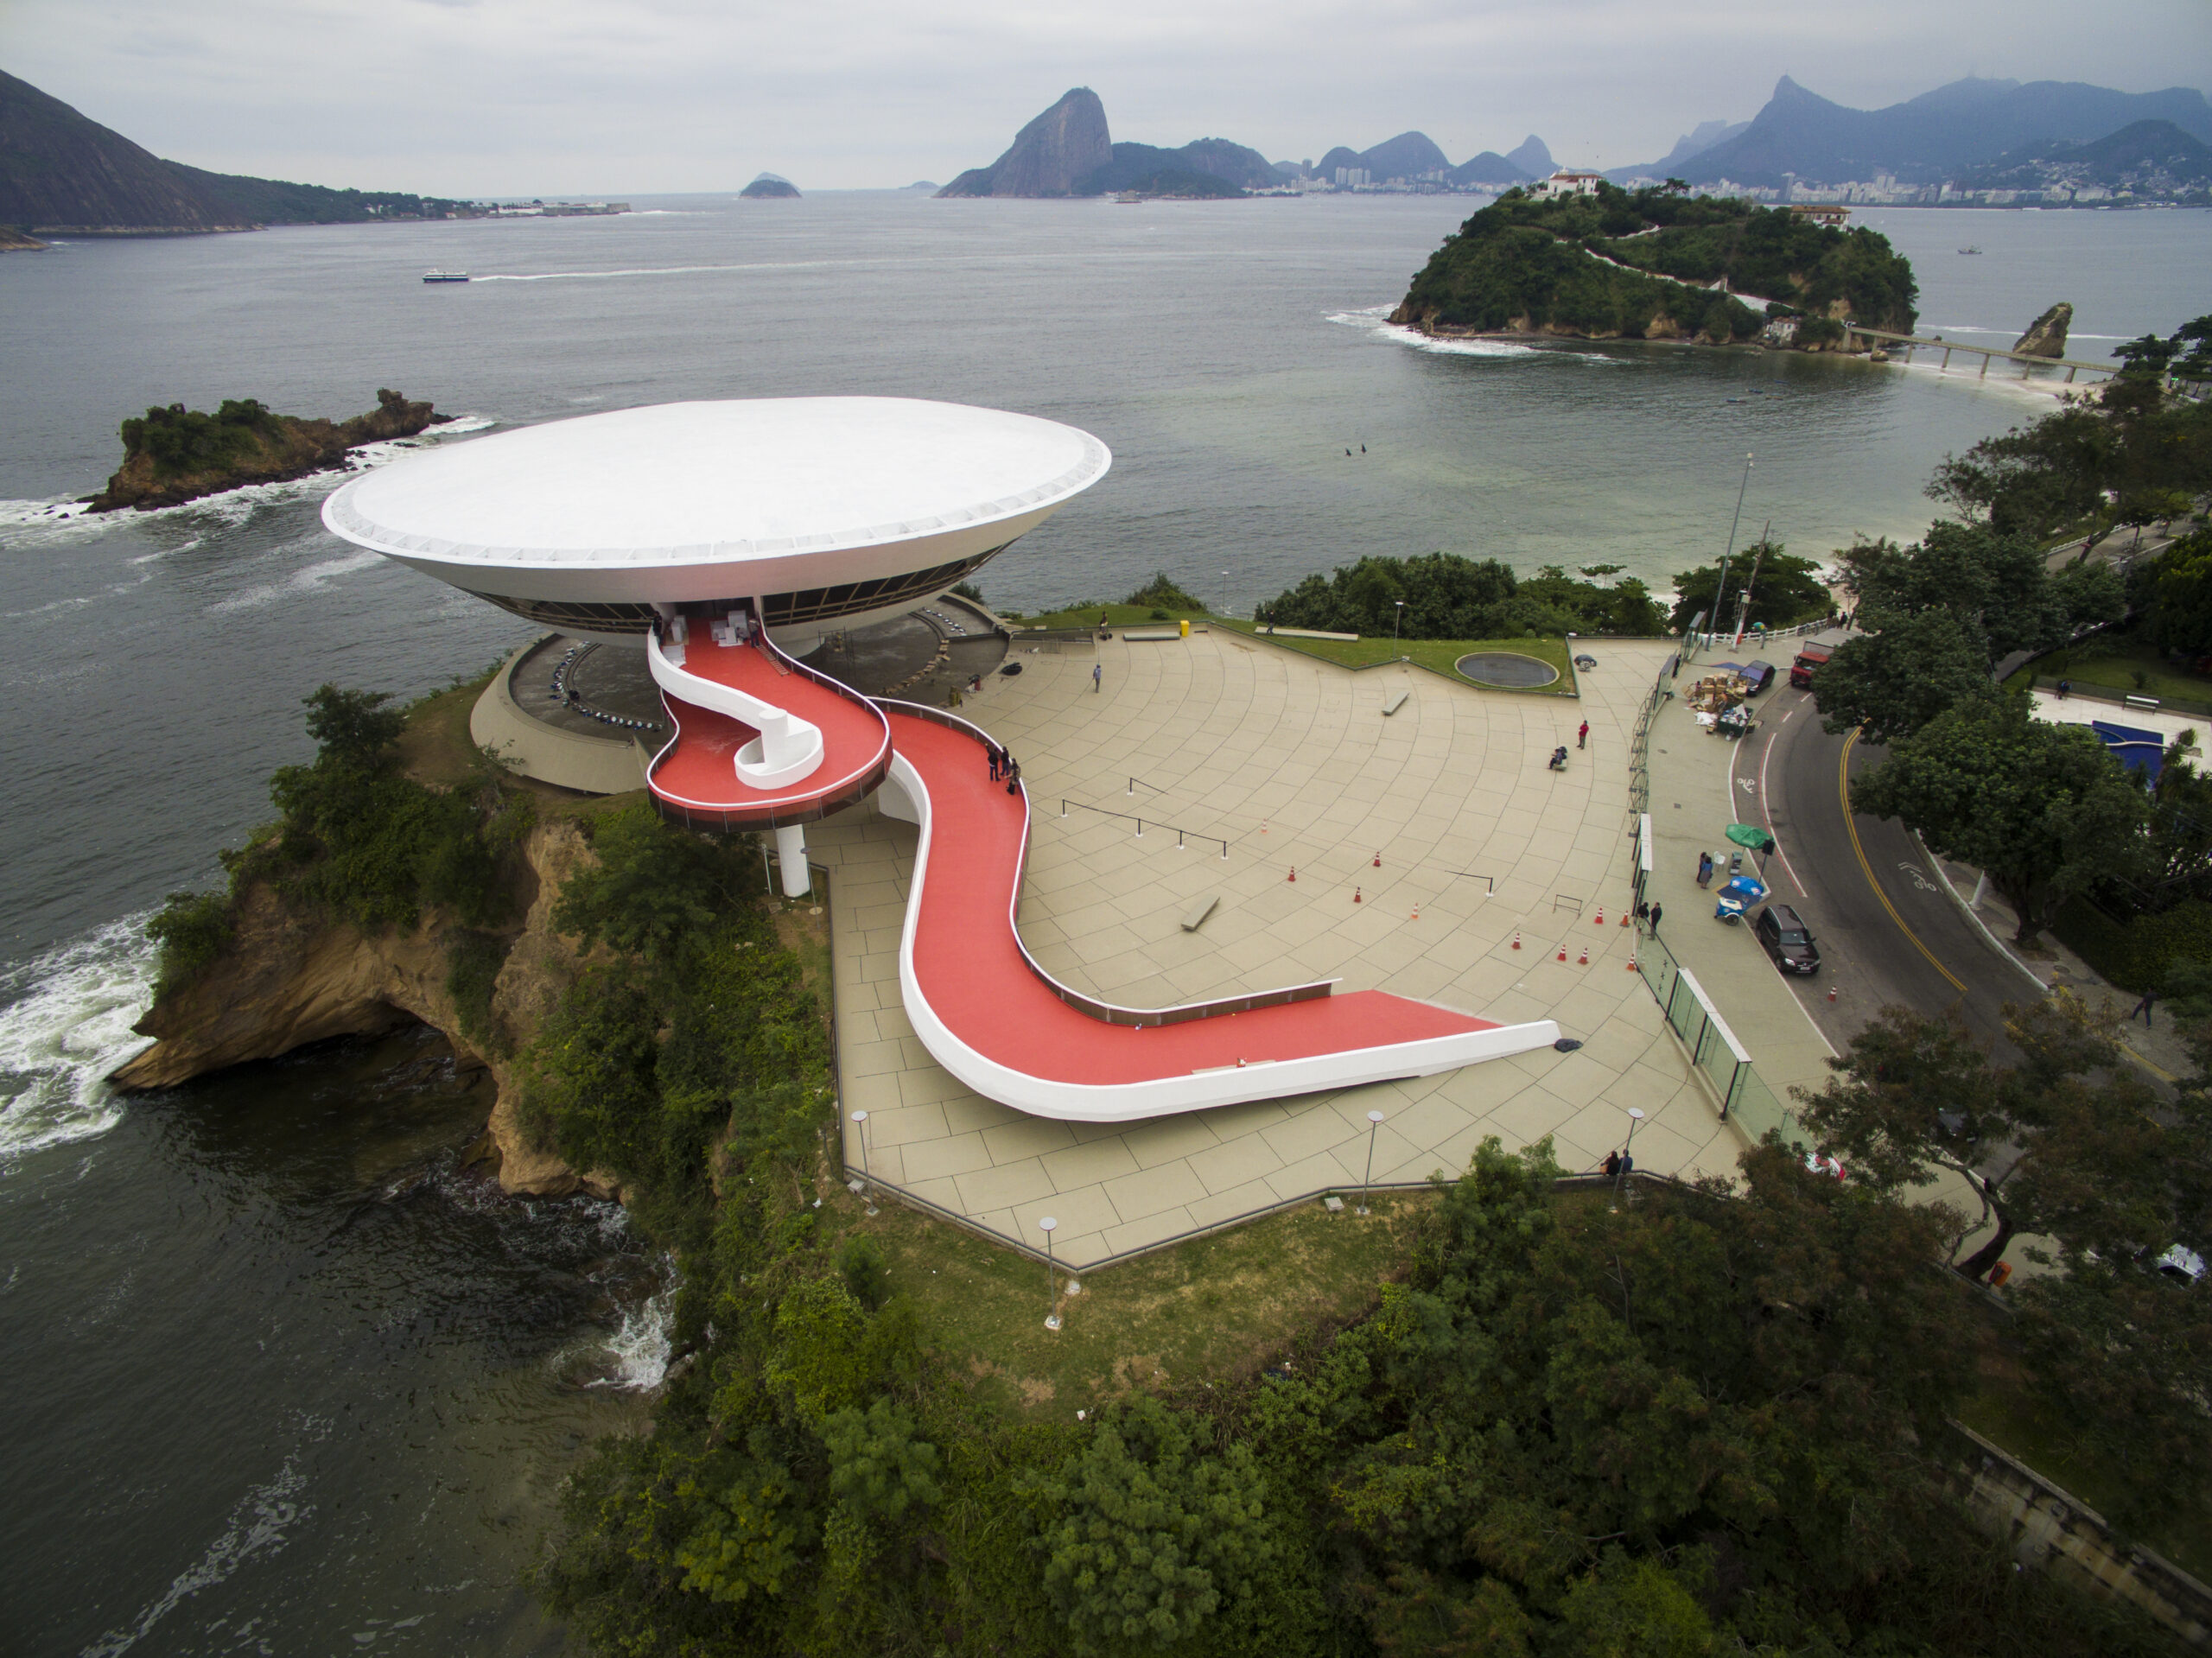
[149,685,537,1008]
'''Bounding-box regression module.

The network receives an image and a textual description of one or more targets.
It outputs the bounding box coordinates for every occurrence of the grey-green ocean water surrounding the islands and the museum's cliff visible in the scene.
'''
[0,194,2212,1654]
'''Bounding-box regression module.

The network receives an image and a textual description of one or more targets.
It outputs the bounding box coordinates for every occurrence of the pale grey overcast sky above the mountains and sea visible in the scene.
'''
[0,0,2212,197]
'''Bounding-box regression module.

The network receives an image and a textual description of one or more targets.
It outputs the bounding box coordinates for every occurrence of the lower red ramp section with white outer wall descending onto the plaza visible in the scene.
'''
[882,703,1560,1123]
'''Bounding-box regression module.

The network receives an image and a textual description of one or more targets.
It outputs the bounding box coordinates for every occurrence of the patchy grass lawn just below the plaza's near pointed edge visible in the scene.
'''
[838,1191,1433,1421]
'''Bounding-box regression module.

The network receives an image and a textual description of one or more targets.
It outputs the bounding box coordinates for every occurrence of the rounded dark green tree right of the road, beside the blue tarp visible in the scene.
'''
[1852,692,2145,944]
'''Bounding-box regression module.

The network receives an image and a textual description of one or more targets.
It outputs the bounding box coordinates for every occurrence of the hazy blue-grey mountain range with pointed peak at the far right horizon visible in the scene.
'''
[1675,75,2212,187]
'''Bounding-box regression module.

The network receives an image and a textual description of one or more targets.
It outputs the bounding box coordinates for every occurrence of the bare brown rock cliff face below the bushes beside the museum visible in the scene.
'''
[113,820,620,1196]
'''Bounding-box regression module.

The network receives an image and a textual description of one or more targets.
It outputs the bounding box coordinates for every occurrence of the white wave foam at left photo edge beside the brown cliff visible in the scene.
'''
[0,915,155,1163]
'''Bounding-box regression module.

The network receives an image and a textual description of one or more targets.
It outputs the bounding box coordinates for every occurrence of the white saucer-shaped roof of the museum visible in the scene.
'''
[323,398,1113,570]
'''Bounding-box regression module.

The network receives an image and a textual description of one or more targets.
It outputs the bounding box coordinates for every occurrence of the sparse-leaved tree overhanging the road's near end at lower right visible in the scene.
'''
[1796,997,2196,1278]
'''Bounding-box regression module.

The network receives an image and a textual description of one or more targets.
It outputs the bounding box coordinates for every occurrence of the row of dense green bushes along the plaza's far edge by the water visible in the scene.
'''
[1259,553,1668,638]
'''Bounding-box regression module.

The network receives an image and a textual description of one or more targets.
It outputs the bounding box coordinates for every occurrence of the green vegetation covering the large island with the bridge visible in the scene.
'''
[1394,183,1918,343]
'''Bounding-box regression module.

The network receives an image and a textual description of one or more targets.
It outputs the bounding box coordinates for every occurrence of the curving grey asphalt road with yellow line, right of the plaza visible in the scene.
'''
[1730,683,2037,1059]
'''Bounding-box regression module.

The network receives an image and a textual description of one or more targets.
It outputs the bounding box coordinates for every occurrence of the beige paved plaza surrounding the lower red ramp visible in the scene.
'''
[807,632,1738,1267]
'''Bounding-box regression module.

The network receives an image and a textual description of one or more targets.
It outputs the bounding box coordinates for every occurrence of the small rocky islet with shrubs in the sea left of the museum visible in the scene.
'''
[88,391,440,513]
